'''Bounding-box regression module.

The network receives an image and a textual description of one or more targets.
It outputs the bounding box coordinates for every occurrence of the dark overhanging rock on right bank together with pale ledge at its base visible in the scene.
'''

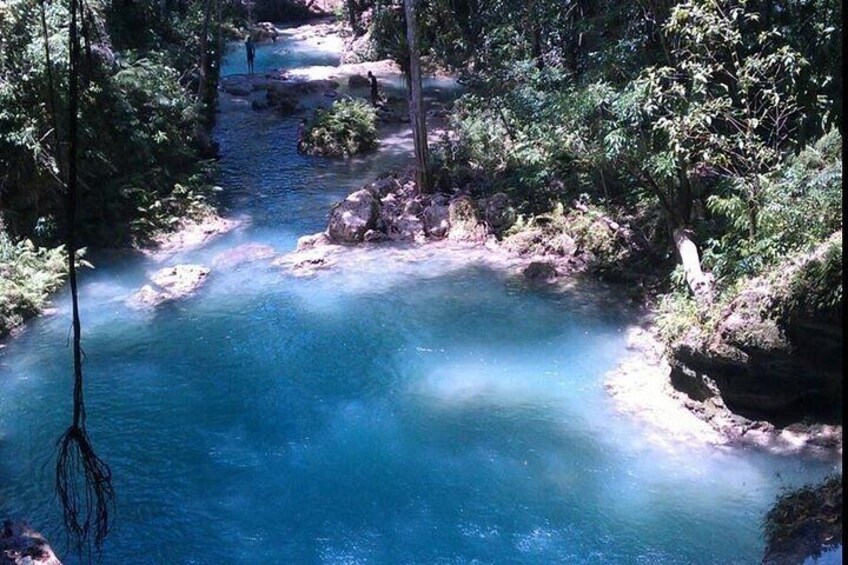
[669,232,843,453]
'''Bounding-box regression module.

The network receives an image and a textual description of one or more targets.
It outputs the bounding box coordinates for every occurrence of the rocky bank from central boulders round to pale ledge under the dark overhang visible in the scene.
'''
[275,165,842,458]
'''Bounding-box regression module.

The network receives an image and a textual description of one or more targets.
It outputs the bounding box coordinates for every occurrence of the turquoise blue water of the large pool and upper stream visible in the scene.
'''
[0,25,831,564]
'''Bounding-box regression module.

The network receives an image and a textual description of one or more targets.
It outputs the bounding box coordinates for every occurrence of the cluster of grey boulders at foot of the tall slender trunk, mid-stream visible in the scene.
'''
[279,169,652,284]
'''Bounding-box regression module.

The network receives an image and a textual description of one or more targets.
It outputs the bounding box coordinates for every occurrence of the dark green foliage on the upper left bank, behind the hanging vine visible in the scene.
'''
[0,0,226,245]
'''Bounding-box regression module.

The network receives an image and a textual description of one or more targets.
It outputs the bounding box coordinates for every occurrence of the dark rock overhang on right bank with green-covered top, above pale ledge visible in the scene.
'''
[671,231,843,425]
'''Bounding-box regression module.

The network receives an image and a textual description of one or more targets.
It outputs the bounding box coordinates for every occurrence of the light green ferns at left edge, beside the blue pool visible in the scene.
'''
[0,230,67,337]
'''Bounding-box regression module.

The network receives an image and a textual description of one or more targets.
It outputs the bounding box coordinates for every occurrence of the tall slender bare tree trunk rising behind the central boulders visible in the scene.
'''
[403,0,430,192]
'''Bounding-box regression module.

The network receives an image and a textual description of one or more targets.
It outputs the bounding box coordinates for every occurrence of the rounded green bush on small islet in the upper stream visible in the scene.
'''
[303,98,377,157]
